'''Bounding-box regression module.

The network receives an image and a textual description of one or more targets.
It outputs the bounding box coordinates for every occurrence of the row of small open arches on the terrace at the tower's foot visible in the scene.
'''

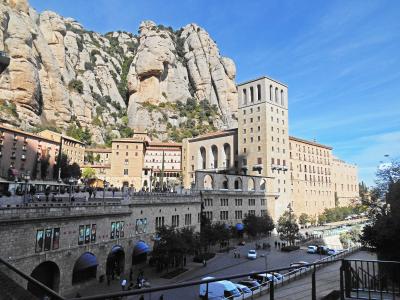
[203,174,267,191]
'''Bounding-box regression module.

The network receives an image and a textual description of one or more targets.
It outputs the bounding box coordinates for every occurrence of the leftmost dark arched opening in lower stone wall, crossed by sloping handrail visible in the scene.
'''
[27,261,60,299]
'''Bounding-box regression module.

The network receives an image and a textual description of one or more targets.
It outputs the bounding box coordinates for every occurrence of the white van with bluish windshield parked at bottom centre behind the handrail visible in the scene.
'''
[199,277,241,300]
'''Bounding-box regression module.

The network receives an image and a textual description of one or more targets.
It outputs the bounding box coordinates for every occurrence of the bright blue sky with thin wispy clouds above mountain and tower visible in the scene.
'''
[30,0,400,185]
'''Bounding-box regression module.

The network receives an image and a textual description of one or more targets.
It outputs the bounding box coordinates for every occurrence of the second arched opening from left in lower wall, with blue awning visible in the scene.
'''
[72,252,98,284]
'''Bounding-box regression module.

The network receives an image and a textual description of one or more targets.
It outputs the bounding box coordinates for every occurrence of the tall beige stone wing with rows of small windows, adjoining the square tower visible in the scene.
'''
[289,137,335,217]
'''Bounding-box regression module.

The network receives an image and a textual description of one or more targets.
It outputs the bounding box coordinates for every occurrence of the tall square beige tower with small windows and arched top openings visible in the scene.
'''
[237,77,290,218]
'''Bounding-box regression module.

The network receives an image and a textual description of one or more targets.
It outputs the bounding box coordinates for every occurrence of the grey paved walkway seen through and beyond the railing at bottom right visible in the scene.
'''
[259,251,376,300]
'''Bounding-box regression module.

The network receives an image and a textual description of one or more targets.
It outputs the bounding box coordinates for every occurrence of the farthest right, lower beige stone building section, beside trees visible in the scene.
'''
[332,157,359,206]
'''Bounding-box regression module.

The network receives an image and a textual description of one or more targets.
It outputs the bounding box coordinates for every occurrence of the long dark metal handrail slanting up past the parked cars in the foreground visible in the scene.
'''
[68,247,359,300]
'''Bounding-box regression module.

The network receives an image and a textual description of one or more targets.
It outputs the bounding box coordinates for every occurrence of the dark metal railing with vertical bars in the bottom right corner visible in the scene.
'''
[340,259,400,299]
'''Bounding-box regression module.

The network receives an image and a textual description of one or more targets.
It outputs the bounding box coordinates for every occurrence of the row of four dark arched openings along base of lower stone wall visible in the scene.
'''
[27,241,149,298]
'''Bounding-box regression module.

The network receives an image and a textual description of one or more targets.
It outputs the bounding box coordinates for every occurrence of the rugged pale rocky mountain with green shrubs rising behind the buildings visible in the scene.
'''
[0,0,237,143]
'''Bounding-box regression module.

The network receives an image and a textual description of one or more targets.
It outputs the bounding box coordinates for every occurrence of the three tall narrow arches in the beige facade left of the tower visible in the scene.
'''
[197,143,232,170]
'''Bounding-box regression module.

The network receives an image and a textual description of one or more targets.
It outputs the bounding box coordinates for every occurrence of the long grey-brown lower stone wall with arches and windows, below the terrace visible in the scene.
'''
[0,193,201,295]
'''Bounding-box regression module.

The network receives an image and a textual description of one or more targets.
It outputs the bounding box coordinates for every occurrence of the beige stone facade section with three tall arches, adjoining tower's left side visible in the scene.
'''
[182,129,238,188]
